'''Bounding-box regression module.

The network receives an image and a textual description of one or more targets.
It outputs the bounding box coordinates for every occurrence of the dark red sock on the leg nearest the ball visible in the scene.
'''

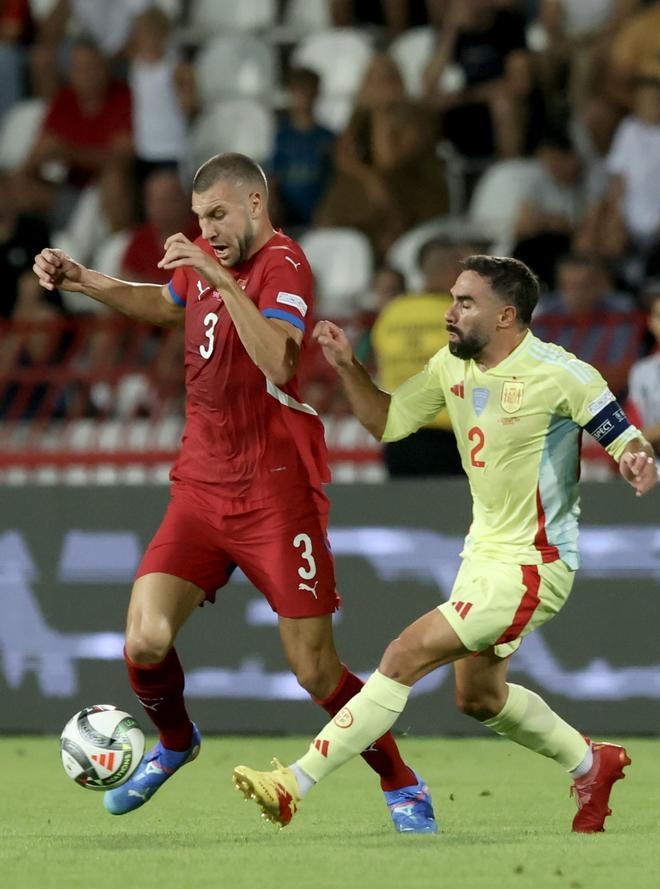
[124,648,192,750]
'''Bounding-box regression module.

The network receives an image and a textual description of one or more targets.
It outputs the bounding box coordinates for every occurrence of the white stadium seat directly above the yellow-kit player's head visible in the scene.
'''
[468,158,538,254]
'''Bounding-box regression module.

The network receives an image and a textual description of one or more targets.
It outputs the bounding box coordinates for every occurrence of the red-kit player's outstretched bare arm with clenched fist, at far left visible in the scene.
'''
[32,247,184,327]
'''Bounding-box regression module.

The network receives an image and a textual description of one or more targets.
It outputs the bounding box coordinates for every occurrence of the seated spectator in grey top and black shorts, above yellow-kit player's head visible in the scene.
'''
[513,133,585,289]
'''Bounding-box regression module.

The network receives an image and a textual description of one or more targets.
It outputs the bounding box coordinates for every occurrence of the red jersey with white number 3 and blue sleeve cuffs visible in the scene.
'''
[169,232,330,501]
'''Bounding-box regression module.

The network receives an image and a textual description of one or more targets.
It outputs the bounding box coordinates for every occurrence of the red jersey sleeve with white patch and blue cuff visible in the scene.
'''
[259,251,314,333]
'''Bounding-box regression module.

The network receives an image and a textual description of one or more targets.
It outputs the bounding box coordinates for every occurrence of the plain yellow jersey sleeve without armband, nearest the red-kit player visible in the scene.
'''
[382,349,446,442]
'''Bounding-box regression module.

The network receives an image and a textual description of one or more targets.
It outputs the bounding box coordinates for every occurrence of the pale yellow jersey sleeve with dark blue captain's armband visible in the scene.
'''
[561,358,642,462]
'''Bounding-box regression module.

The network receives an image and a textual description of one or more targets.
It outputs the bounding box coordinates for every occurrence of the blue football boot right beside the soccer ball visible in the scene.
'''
[103,722,202,815]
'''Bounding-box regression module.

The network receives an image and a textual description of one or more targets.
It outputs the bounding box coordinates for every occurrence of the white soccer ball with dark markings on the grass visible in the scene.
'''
[60,704,144,790]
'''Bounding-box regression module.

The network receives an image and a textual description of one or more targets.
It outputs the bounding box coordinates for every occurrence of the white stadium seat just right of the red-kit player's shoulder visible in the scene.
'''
[300,228,373,318]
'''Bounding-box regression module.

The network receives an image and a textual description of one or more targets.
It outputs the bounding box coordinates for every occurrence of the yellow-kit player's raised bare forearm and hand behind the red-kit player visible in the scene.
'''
[313,321,390,441]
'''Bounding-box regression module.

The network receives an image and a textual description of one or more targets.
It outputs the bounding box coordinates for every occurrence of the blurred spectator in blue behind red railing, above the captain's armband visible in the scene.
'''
[532,254,644,394]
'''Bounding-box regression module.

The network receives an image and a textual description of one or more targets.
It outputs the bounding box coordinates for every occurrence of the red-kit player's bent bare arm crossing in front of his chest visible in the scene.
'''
[158,232,303,386]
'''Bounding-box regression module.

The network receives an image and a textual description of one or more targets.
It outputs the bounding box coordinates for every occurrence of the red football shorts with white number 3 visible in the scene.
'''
[136,489,341,617]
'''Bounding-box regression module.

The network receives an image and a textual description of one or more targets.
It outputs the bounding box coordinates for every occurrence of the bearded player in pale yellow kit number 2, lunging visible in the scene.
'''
[234,256,658,833]
